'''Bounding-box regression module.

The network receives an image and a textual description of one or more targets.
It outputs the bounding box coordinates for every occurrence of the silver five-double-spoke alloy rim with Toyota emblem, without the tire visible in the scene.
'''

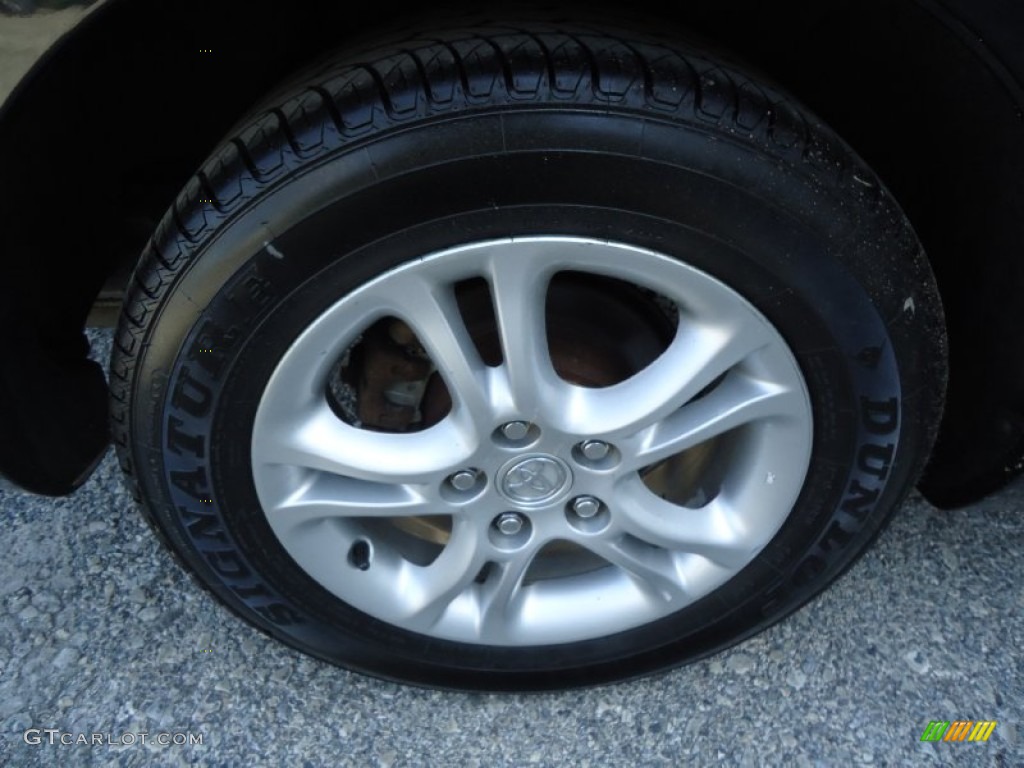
[252,237,812,646]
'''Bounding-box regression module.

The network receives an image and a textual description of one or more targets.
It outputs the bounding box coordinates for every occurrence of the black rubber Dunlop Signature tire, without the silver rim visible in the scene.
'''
[111,26,945,689]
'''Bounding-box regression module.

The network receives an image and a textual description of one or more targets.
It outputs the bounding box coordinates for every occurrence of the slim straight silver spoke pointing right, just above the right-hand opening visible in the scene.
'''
[620,373,805,471]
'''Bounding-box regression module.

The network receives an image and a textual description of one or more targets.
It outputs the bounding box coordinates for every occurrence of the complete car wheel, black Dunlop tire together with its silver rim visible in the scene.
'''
[112,26,945,689]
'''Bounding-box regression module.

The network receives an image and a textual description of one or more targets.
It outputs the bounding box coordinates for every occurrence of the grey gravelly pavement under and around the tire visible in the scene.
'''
[0,332,1024,768]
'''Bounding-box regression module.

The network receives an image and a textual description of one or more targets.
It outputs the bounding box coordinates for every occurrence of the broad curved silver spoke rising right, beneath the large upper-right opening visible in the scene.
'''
[561,322,770,439]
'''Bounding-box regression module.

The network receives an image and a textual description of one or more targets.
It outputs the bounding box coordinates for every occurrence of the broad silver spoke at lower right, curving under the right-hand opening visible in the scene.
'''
[614,475,774,568]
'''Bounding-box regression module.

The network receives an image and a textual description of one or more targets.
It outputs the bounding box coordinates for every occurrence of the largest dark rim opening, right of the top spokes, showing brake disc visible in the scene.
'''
[545,271,679,388]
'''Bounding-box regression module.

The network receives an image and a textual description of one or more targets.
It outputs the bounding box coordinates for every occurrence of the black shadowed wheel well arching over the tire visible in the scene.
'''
[0,0,1024,504]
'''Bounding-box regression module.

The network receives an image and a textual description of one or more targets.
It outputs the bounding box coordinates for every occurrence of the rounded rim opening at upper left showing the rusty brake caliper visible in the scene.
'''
[327,317,452,432]
